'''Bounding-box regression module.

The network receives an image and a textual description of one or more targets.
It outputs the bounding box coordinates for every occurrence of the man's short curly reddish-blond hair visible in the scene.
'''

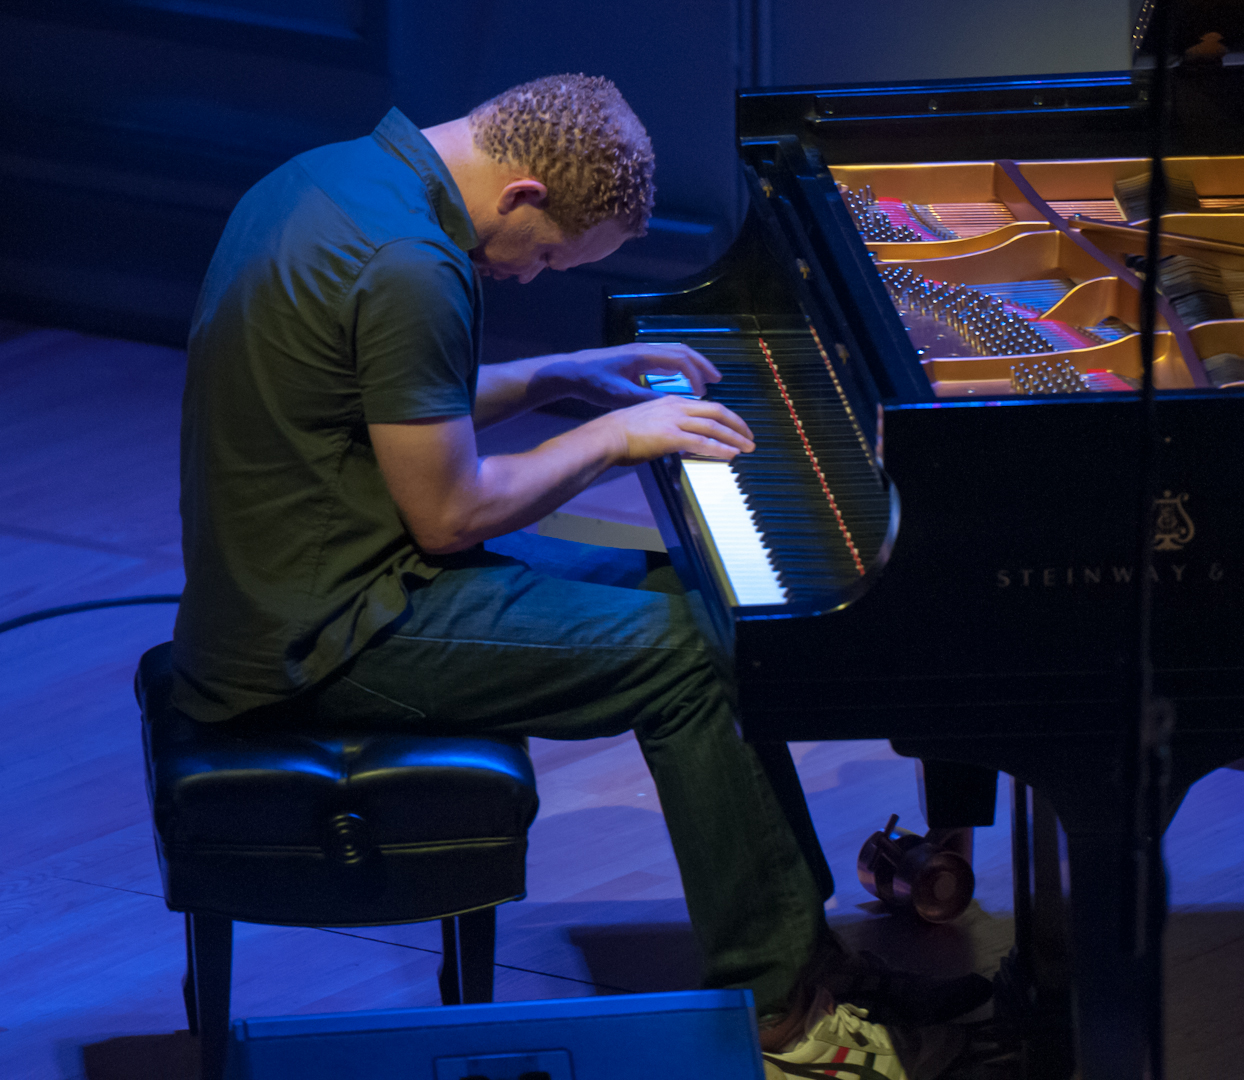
[467,75,656,236]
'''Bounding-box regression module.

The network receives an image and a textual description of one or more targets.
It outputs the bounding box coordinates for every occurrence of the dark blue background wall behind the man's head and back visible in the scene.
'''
[0,0,1132,358]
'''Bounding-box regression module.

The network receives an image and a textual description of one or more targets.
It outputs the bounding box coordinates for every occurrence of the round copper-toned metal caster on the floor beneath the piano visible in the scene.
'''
[856,814,977,923]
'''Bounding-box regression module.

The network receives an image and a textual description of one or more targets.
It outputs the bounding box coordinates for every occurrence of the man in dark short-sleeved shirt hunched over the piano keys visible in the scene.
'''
[174,76,988,1076]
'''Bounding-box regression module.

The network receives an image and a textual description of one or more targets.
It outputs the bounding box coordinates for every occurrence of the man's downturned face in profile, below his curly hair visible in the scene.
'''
[470,207,629,285]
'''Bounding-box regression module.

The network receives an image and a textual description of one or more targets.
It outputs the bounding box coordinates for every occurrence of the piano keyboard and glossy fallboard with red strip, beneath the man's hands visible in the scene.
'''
[638,319,891,606]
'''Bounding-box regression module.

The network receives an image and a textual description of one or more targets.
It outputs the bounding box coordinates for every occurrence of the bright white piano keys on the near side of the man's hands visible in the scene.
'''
[683,459,787,606]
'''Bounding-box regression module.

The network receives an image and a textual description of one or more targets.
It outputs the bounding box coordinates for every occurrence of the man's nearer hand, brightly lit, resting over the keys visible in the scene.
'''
[585,394,756,465]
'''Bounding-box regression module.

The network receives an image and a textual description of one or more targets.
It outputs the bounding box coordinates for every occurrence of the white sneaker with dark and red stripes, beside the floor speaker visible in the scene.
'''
[764,1005,911,1080]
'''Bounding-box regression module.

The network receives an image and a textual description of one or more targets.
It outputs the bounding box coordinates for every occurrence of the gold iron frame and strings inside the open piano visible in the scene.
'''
[831,157,1244,397]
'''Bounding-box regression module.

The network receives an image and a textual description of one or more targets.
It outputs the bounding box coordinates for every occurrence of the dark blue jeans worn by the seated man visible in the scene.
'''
[317,538,829,1017]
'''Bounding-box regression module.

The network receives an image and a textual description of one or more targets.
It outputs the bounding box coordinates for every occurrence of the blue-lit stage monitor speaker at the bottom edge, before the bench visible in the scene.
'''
[226,990,764,1080]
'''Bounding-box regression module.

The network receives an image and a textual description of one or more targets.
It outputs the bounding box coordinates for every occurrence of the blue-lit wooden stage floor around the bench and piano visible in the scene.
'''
[0,324,1244,1080]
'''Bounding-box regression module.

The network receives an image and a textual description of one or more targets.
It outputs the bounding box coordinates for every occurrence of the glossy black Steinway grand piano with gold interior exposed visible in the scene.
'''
[607,63,1244,1080]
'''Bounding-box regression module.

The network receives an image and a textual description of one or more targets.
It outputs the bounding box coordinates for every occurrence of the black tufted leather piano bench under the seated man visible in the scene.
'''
[134,642,539,1080]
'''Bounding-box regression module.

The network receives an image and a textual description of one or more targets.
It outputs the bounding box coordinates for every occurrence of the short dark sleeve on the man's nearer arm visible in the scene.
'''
[347,239,478,423]
